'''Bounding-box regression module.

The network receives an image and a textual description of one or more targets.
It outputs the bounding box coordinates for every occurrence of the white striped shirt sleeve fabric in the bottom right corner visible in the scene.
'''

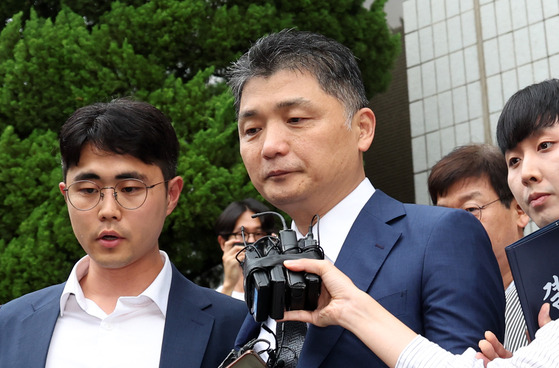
[396,320,559,368]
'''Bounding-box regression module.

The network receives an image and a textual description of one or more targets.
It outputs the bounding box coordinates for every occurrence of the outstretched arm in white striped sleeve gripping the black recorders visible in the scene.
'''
[284,259,559,368]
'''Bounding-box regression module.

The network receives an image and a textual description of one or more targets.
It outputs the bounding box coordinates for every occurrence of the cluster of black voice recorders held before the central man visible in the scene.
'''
[241,211,324,322]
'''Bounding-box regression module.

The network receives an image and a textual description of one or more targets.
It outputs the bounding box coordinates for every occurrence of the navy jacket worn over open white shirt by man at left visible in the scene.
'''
[0,266,247,368]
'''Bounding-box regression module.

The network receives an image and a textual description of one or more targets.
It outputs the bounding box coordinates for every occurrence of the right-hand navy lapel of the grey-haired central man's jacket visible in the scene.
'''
[299,189,405,367]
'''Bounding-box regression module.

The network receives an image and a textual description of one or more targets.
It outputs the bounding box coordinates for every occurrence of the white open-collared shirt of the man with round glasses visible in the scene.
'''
[46,251,172,368]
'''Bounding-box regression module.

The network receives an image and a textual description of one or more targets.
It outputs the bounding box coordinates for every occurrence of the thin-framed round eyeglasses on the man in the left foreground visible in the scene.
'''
[64,179,167,211]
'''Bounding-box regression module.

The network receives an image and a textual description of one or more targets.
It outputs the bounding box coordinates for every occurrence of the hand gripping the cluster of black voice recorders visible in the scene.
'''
[283,259,362,327]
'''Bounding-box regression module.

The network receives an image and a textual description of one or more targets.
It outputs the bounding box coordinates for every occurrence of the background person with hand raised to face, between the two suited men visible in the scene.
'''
[214,198,276,300]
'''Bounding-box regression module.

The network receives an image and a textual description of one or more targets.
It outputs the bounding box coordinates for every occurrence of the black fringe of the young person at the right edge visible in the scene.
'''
[497,79,559,153]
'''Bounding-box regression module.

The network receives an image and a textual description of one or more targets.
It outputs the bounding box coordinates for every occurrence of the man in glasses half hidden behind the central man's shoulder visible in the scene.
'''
[428,144,529,351]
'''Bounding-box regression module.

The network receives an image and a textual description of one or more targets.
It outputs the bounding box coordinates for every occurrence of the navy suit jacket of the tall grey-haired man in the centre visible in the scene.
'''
[235,190,505,368]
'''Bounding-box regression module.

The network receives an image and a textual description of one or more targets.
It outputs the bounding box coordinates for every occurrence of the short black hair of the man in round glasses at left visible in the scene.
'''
[59,98,179,180]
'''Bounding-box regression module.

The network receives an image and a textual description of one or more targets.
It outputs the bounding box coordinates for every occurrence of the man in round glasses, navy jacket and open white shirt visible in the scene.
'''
[0,99,247,368]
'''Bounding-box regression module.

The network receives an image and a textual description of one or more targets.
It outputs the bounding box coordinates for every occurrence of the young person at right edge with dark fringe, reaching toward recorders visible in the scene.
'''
[284,79,559,368]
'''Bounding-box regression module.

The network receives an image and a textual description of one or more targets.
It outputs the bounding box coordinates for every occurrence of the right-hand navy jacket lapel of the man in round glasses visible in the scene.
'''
[159,266,214,368]
